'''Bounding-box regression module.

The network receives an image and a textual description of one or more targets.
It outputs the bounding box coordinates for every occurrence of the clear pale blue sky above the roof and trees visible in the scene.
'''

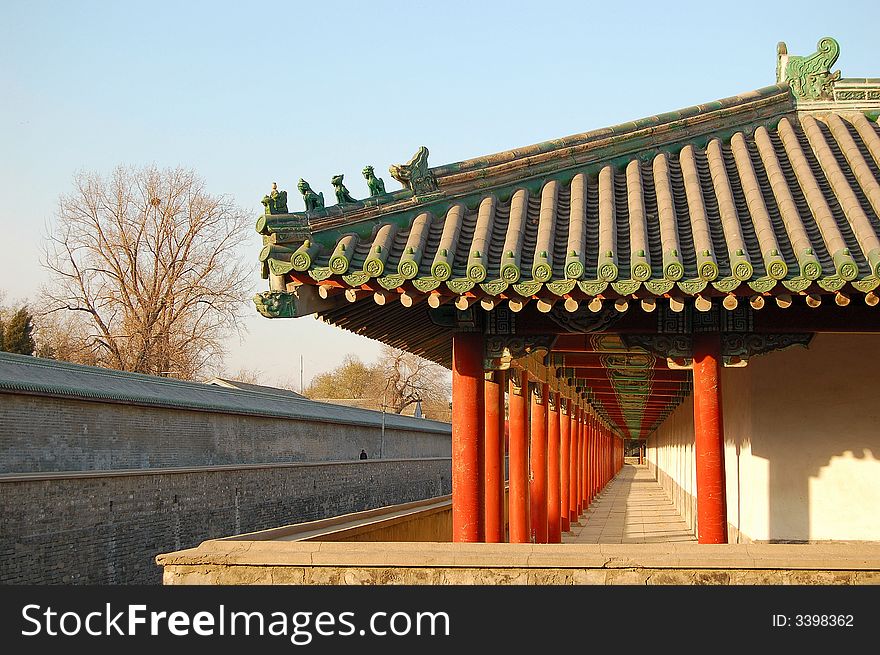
[0,0,880,387]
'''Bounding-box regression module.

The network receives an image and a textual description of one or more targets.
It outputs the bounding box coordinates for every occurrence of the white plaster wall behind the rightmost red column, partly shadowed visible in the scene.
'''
[647,334,880,543]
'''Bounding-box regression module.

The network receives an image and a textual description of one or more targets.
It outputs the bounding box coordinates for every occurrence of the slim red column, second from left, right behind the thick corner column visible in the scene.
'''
[484,371,506,543]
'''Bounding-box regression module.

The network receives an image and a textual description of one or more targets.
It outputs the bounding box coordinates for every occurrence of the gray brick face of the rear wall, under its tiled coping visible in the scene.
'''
[0,393,451,473]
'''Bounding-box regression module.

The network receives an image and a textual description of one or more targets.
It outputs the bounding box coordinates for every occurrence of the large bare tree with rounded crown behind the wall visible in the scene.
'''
[43,167,252,379]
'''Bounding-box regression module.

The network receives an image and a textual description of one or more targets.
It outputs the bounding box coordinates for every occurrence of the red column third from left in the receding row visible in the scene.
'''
[507,371,530,544]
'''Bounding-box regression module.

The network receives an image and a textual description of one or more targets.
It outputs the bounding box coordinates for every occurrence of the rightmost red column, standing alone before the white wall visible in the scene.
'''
[693,333,727,544]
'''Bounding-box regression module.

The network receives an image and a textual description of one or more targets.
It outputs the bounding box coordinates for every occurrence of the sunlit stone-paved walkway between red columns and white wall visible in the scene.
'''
[562,464,697,544]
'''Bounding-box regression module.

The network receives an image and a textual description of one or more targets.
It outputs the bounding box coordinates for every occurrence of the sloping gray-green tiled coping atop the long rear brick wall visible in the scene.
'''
[0,352,450,433]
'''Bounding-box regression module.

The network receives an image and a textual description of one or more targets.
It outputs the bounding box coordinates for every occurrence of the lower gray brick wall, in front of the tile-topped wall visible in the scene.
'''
[0,458,452,584]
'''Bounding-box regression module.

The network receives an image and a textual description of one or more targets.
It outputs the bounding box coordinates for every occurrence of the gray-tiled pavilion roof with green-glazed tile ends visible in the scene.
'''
[260,85,880,304]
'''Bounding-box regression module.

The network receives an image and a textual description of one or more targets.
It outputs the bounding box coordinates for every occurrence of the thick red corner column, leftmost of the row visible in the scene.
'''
[452,332,485,542]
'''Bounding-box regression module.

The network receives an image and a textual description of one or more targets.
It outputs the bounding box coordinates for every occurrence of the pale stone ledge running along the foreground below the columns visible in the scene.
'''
[156,540,880,584]
